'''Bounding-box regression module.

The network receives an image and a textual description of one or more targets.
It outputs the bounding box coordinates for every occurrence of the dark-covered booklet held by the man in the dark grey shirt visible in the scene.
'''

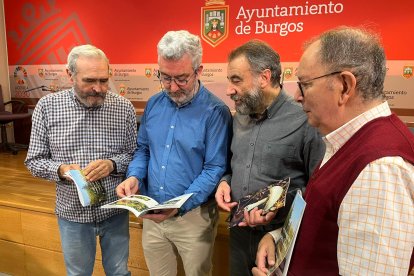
[227,178,290,228]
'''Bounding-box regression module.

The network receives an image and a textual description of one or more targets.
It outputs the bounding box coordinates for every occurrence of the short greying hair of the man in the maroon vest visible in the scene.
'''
[306,26,386,100]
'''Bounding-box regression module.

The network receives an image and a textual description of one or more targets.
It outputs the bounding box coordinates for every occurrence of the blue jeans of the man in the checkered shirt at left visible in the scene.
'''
[58,212,131,276]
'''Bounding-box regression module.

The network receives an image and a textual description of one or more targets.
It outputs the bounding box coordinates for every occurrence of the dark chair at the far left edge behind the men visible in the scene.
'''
[0,85,31,155]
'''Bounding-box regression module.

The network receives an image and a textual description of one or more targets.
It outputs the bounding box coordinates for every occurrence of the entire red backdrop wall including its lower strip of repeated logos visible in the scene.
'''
[4,0,414,109]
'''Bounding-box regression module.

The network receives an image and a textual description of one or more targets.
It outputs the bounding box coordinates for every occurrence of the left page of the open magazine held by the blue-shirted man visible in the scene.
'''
[101,195,158,217]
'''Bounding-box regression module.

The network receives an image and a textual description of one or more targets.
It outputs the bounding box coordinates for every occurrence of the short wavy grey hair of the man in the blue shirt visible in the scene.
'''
[157,30,203,70]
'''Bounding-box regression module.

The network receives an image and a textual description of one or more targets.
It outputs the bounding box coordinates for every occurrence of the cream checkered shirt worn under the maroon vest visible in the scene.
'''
[322,102,414,275]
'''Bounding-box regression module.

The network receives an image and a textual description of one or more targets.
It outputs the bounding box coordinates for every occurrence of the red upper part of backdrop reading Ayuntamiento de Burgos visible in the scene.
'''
[4,0,414,65]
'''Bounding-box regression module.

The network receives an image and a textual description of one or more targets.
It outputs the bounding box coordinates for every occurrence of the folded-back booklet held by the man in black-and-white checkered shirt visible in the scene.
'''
[65,170,107,207]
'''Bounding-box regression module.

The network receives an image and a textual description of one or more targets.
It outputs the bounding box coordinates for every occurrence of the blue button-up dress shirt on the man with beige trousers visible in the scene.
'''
[127,84,232,213]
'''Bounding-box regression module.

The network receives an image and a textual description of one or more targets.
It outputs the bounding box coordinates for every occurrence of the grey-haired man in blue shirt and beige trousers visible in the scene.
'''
[117,31,232,276]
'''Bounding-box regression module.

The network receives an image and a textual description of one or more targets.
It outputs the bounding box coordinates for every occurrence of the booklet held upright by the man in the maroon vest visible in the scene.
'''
[267,190,306,276]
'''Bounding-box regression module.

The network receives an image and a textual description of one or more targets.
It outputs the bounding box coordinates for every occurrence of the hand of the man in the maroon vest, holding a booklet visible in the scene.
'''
[252,234,275,276]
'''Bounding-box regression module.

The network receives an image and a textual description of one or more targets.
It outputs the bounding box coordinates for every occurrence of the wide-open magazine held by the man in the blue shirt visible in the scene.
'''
[101,193,193,217]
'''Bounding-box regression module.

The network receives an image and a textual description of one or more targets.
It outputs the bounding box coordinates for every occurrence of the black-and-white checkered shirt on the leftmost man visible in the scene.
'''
[25,89,137,223]
